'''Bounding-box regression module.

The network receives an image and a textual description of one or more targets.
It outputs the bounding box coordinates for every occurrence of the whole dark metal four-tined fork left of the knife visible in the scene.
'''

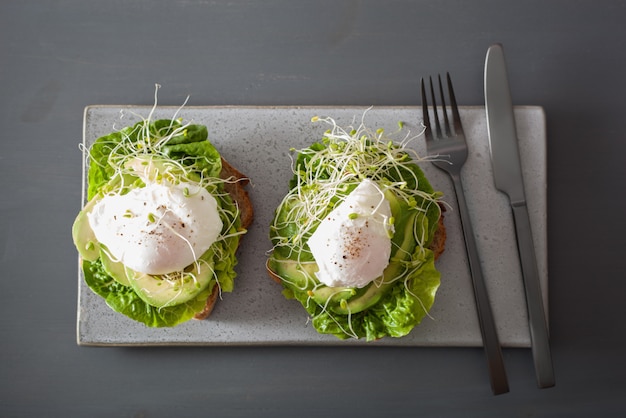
[421,73,509,395]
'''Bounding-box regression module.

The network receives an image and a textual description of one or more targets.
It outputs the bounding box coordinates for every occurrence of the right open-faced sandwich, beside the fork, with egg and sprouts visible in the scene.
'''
[267,113,446,341]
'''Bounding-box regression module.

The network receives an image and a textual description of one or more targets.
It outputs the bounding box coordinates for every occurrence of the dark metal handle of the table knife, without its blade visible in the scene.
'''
[511,203,555,388]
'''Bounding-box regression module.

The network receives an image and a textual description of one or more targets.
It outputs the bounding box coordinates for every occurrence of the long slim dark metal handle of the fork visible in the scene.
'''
[450,174,509,395]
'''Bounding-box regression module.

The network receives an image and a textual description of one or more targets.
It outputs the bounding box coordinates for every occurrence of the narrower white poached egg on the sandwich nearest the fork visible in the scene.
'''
[308,179,393,288]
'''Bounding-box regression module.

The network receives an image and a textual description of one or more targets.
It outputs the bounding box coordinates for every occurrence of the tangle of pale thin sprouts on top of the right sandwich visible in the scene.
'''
[272,112,440,260]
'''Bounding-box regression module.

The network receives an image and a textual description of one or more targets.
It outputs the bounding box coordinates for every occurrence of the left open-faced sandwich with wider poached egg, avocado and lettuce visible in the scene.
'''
[72,108,253,327]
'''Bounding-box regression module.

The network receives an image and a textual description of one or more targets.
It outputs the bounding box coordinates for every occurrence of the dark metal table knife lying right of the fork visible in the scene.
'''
[485,44,555,388]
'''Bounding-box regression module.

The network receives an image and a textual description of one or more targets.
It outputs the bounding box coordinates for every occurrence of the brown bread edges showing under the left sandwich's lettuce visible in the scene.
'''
[194,157,254,319]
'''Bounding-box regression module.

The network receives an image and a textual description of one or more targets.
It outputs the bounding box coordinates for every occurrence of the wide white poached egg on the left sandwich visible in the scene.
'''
[87,181,222,275]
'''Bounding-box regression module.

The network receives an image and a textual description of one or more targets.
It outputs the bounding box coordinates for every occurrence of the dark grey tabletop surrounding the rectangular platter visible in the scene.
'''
[0,0,626,417]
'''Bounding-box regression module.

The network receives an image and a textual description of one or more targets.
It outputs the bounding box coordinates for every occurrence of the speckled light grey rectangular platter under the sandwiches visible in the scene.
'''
[77,106,548,347]
